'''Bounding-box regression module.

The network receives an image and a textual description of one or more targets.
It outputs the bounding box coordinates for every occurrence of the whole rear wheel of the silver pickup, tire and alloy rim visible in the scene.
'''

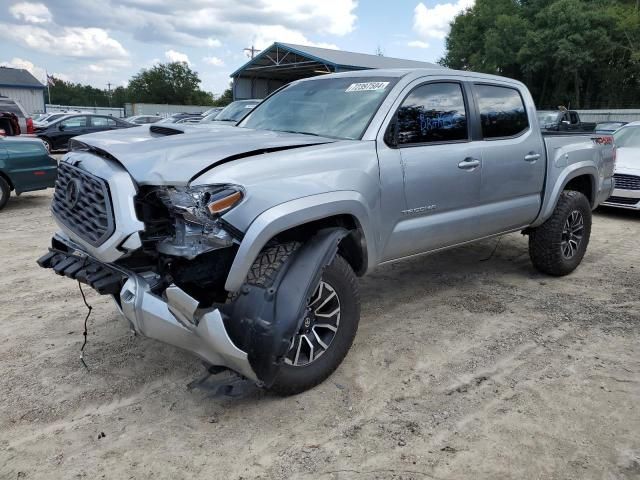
[529,190,591,277]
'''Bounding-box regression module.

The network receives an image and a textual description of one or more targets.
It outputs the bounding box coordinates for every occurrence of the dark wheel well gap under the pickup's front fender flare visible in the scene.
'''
[269,214,367,276]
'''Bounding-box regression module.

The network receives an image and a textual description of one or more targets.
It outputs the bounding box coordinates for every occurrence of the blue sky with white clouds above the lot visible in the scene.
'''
[0,0,474,94]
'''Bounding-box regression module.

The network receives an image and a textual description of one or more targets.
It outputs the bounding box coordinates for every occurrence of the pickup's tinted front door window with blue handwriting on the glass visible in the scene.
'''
[398,83,469,145]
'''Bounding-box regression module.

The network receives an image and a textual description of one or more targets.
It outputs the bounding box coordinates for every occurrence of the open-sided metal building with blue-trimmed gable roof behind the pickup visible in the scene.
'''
[231,42,442,100]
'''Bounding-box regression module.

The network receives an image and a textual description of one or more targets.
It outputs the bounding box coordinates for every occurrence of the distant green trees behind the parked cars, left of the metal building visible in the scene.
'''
[45,62,233,107]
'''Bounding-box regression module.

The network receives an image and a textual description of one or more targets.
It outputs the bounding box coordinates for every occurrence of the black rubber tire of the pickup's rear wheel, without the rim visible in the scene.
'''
[529,190,591,277]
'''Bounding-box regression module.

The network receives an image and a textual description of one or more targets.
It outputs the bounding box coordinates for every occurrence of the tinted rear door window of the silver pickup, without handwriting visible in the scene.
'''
[474,84,529,139]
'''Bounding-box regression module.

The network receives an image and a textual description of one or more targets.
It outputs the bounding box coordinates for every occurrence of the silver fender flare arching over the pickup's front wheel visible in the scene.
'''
[225,190,377,292]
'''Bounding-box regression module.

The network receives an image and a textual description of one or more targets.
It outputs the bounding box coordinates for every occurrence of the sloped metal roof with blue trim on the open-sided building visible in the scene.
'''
[231,42,443,77]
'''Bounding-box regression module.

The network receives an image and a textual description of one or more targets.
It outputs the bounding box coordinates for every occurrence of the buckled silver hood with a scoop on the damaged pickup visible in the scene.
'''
[75,124,334,185]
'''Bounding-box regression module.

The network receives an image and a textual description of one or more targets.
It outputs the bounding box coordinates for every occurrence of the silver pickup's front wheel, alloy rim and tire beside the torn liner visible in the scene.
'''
[271,255,360,395]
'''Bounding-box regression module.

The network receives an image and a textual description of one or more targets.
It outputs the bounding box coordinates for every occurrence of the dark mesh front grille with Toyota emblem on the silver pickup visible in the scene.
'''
[51,162,115,247]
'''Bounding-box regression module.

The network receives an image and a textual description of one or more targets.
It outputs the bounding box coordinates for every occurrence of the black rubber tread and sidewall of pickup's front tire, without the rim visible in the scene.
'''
[247,246,360,396]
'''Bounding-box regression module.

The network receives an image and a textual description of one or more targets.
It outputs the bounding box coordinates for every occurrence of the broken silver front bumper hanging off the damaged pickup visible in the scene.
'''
[38,236,259,381]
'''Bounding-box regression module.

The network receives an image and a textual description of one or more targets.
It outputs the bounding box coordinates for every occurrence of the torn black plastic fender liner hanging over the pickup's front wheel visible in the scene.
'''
[221,228,349,387]
